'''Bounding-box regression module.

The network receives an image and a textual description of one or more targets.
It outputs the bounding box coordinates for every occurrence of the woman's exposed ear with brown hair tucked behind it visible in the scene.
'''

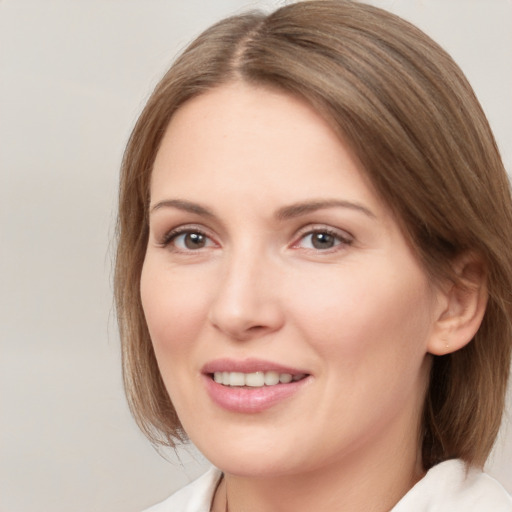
[427,253,488,355]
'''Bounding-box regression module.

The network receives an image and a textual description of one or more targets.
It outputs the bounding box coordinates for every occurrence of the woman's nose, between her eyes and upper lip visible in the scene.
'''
[209,249,285,341]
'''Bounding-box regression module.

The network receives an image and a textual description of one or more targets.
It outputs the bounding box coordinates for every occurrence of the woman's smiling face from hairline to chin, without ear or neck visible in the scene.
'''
[141,84,444,475]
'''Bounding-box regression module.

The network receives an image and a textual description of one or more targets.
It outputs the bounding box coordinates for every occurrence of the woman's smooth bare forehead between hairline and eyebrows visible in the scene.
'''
[151,83,382,211]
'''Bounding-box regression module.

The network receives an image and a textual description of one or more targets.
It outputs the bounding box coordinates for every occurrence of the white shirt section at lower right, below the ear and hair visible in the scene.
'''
[392,460,512,512]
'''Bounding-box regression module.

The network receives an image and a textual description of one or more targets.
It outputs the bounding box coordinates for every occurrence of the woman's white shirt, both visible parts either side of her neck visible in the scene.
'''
[145,460,512,512]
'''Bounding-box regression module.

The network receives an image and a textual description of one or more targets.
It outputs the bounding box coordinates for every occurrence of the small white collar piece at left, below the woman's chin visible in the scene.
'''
[144,468,222,512]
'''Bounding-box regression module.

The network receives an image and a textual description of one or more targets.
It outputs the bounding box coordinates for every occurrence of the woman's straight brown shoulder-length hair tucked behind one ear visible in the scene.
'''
[115,0,512,469]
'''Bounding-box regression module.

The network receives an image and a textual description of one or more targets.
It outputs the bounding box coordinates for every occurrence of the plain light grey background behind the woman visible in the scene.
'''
[0,0,512,512]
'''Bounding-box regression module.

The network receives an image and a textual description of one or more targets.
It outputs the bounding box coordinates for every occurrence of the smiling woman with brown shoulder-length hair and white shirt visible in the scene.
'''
[116,0,512,512]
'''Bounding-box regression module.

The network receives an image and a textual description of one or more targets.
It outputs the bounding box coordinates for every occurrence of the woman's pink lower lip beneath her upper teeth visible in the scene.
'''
[203,375,309,413]
